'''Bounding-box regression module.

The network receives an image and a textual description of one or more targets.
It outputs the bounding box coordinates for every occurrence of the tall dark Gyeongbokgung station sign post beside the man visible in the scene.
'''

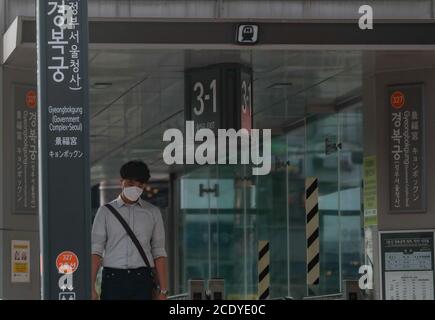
[37,0,91,300]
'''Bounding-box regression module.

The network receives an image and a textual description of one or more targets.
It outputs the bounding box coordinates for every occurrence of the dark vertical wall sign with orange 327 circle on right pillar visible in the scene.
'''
[388,85,426,212]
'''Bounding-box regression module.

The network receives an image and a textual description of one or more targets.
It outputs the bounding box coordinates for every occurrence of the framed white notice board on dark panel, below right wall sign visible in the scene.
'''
[380,232,434,300]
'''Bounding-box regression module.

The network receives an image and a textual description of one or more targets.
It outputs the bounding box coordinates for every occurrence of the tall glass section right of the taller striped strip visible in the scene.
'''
[305,102,363,294]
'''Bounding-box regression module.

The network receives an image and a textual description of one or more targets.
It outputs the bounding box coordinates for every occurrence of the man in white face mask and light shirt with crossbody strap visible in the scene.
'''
[92,161,168,300]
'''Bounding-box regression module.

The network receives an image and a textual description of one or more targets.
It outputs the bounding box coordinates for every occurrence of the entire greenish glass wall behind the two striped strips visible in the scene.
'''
[179,103,363,299]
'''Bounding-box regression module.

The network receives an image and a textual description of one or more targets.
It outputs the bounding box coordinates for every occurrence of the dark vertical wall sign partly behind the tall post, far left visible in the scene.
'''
[14,85,38,214]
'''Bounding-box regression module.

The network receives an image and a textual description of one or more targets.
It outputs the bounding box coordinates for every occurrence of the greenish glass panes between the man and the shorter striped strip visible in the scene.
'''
[179,166,257,299]
